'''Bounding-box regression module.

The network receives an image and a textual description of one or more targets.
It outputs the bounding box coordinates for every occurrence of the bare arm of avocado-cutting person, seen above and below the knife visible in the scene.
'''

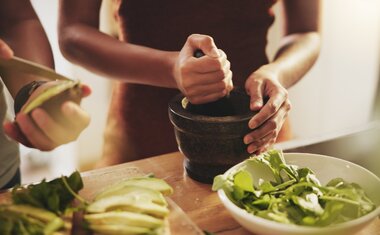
[0,0,54,97]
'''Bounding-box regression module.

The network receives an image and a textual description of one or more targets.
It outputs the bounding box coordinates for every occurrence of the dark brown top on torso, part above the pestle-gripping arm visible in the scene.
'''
[116,0,275,86]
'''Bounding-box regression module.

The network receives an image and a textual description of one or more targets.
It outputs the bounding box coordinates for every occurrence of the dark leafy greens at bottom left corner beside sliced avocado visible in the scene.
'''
[0,171,83,235]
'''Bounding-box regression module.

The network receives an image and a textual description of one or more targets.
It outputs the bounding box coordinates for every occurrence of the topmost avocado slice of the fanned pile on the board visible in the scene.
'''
[95,177,173,200]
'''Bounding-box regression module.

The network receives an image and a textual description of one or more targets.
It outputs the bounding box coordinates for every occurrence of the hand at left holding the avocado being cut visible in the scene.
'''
[3,82,91,151]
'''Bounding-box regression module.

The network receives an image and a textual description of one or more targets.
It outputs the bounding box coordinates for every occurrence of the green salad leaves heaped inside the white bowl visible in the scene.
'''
[213,150,376,226]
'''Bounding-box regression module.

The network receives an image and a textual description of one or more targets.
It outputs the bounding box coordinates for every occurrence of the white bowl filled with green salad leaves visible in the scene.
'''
[213,150,380,235]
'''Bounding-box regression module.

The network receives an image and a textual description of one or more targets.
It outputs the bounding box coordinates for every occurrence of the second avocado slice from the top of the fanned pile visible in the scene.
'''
[95,185,167,206]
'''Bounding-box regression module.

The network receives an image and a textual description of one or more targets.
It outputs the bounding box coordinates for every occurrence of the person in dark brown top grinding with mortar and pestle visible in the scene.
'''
[59,0,320,166]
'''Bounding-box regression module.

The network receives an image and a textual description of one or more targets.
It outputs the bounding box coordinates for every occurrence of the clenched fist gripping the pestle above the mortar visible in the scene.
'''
[174,34,233,104]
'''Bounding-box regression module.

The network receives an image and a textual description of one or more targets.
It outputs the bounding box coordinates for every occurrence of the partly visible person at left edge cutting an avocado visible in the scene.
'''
[0,0,91,189]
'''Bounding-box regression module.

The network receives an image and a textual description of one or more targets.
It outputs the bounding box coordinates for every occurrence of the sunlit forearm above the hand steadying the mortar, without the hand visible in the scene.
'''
[265,32,320,88]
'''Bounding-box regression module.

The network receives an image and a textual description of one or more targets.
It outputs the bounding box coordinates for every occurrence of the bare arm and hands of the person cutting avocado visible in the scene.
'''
[0,0,91,151]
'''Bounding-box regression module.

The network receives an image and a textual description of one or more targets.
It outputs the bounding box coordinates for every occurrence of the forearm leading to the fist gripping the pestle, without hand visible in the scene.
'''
[59,24,178,88]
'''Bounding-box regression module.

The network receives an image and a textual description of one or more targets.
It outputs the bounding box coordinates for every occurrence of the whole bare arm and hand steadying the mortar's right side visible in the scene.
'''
[244,0,320,153]
